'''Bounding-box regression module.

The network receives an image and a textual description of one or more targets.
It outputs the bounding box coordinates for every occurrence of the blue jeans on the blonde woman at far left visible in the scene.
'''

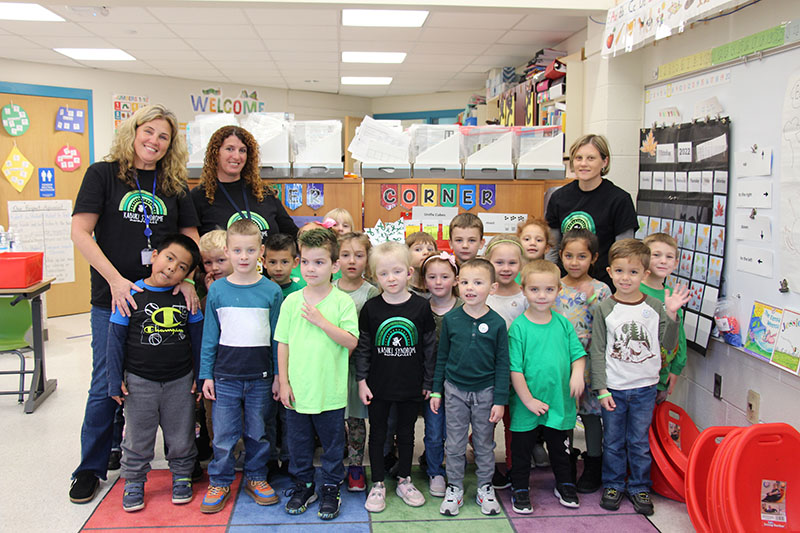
[72,306,117,479]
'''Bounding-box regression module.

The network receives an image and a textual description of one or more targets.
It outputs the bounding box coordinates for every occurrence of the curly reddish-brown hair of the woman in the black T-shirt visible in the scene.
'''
[200,126,275,204]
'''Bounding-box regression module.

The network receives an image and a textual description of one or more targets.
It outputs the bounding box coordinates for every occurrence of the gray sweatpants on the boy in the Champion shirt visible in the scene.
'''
[120,372,197,482]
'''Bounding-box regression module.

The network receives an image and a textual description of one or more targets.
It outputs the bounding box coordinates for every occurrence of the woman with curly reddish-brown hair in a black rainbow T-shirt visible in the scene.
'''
[191,126,297,239]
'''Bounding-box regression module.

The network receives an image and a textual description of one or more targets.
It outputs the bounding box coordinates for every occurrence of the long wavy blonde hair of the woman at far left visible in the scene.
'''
[104,104,189,196]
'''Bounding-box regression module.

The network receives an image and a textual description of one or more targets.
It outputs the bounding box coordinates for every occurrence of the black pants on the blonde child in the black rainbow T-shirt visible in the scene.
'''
[369,398,419,483]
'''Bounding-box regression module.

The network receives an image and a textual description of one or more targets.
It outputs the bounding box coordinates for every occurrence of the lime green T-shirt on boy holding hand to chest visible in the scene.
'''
[275,287,358,414]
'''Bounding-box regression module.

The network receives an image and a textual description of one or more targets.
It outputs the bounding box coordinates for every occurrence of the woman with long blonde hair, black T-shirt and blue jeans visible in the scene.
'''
[69,104,199,503]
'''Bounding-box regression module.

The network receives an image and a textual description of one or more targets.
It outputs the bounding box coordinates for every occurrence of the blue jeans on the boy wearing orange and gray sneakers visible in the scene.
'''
[208,376,272,487]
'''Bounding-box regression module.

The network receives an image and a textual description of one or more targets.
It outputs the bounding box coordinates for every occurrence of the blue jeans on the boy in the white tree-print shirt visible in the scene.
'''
[602,385,656,494]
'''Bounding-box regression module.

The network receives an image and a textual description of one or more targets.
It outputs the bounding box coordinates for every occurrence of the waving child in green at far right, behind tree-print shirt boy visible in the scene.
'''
[639,233,686,403]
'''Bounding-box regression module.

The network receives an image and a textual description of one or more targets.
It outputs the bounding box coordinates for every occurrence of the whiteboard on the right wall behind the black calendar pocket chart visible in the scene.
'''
[644,45,800,370]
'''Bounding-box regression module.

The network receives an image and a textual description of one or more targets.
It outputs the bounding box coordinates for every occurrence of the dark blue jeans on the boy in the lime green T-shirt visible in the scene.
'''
[286,407,345,485]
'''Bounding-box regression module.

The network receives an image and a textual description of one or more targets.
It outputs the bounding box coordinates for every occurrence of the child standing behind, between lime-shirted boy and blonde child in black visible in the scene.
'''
[333,233,381,492]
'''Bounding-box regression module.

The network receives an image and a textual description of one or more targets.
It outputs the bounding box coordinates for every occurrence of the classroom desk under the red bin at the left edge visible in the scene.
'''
[0,278,58,414]
